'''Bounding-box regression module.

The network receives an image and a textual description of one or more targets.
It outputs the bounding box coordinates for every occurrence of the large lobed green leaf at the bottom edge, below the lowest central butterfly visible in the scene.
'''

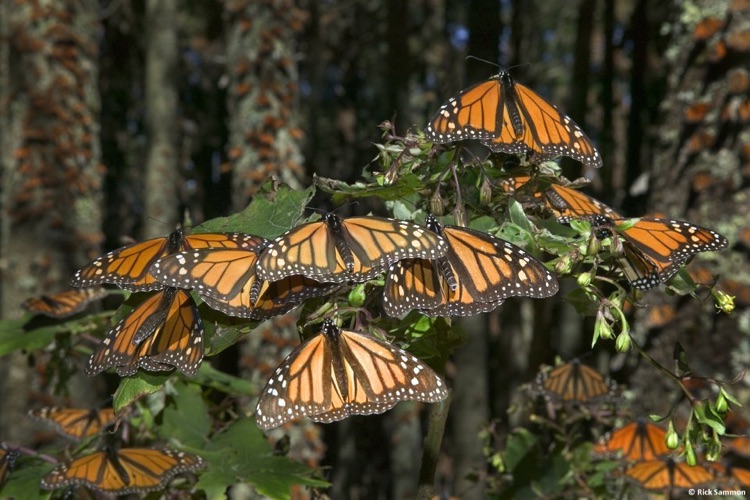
[196,418,330,499]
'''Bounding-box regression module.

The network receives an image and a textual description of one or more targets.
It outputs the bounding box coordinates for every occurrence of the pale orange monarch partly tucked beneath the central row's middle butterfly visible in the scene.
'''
[152,244,337,320]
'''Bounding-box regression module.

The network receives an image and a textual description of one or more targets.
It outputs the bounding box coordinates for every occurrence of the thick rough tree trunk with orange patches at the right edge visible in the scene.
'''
[634,0,750,413]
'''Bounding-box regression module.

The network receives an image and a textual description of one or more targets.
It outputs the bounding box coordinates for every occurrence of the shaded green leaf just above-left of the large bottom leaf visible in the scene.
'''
[157,381,211,448]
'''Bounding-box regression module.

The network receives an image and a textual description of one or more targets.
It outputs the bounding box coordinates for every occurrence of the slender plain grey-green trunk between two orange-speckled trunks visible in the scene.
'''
[143,0,182,238]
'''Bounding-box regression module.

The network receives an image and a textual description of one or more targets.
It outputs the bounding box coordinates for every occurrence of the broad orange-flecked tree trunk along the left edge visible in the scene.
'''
[0,0,103,442]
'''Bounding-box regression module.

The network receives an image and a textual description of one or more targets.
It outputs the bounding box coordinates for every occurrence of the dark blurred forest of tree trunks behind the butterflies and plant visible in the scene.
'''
[0,0,750,498]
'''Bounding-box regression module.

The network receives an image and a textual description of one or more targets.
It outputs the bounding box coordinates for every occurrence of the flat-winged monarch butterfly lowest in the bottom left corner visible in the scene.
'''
[42,448,204,495]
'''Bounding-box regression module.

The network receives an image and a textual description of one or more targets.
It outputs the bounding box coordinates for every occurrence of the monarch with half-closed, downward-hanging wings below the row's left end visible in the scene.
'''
[86,288,204,377]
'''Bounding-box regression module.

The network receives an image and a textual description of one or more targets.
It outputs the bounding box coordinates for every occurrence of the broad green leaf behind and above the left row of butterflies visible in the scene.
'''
[193,183,315,239]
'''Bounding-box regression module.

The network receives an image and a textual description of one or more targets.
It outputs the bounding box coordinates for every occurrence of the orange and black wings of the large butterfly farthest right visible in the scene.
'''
[610,217,729,290]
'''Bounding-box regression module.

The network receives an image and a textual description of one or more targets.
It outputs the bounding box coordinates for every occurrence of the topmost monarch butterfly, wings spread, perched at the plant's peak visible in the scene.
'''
[425,71,602,168]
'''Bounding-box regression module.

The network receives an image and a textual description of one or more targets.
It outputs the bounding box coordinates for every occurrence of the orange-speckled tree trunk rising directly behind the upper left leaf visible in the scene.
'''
[225,0,304,210]
